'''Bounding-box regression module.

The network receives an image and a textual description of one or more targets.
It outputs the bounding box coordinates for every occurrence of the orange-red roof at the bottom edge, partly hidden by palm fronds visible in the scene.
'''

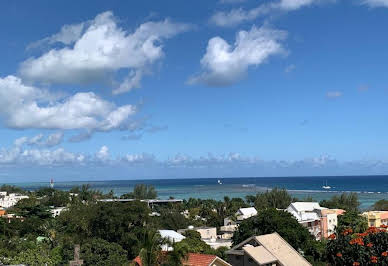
[133,253,232,266]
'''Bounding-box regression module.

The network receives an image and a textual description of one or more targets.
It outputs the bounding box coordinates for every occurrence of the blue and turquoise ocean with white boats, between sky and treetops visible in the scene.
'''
[3,176,388,209]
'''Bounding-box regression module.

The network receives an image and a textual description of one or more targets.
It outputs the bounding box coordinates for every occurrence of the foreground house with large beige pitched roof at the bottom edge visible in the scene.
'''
[226,233,311,266]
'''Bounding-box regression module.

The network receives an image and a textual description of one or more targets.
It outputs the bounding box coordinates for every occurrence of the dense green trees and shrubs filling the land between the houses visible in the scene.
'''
[0,185,388,265]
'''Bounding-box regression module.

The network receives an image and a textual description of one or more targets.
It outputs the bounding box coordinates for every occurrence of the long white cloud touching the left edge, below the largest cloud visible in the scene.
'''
[0,76,136,131]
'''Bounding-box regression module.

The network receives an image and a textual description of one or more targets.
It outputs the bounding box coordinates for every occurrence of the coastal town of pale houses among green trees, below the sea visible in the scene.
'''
[0,184,388,266]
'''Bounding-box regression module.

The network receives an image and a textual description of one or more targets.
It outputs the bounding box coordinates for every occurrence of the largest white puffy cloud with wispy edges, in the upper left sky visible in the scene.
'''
[20,11,190,94]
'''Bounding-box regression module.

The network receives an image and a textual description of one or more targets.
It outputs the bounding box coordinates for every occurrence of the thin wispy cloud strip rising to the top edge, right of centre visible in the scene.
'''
[210,0,332,27]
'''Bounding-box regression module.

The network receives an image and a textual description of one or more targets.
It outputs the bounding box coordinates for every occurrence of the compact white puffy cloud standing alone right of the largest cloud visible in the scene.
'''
[189,26,287,87]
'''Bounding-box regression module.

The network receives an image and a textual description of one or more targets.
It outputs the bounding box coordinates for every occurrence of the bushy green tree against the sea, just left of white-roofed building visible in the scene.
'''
[246,188,292,210]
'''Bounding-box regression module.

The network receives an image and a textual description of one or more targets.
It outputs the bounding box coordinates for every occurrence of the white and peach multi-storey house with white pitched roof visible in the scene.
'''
[286,202,344,240]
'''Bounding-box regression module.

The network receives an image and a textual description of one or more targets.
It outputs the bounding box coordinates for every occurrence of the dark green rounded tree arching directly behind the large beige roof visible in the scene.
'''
[233,209,313,250]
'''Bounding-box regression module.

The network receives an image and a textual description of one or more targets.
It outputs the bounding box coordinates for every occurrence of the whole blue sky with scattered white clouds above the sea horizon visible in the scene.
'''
[0,0,388,183]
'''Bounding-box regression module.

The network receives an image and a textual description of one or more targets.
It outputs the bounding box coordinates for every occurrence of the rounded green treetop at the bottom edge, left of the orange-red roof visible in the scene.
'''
[80,238,128,266]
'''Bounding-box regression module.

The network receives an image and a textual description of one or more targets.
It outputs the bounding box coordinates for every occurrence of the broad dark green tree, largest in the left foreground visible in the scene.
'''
[58,201,150,259]
